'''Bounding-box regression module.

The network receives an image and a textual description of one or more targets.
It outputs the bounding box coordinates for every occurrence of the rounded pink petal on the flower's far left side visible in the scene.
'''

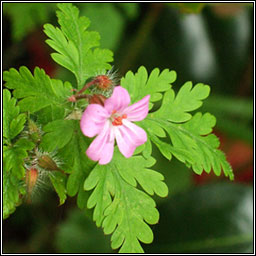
[80,104,109,137]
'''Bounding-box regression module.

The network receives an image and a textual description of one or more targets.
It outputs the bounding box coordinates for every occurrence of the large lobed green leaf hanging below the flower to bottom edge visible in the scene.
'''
[84,149,168,253]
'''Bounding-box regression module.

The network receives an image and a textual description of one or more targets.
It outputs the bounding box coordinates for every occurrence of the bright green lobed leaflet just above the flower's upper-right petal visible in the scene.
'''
[121,66,176,108]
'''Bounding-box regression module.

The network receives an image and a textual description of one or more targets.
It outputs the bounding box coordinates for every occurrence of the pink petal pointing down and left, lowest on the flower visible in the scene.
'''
[86,122,115,165]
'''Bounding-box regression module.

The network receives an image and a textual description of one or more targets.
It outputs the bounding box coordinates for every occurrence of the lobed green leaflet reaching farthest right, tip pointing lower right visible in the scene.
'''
[145,113,234,180]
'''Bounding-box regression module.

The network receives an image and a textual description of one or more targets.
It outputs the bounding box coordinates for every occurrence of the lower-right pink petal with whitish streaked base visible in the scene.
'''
[114,120,147,158]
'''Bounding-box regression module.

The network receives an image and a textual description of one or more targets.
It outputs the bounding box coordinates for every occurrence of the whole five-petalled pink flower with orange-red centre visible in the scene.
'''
[80,86,150,165]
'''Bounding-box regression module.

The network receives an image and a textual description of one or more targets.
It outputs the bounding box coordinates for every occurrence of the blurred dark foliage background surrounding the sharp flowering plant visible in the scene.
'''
[2,3,254,253]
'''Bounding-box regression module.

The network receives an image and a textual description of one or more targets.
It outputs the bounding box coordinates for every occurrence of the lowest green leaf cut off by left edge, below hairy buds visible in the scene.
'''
[3,169,25,219]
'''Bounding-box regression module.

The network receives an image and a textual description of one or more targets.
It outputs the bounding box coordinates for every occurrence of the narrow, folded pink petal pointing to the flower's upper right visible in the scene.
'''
[123,95,150,121]
